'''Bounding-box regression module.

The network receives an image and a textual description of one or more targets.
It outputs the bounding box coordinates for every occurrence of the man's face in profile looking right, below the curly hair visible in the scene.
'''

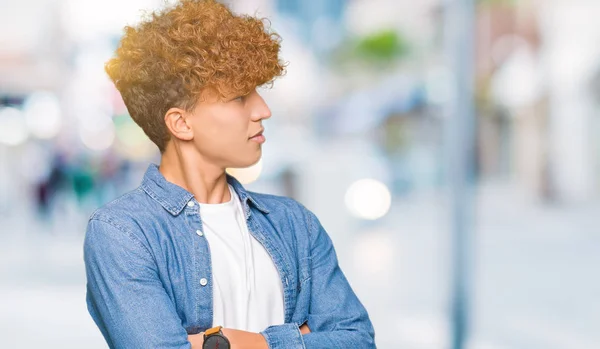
[189,90,271,168]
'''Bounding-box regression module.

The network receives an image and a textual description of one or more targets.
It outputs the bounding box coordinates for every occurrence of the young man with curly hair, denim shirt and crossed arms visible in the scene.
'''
[84,0,375,349]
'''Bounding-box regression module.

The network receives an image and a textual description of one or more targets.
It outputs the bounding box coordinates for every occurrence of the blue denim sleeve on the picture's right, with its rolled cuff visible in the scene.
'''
[262,210,376,349]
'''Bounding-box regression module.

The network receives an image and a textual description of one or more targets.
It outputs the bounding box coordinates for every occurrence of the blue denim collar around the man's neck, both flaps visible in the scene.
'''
[141,164,269,218]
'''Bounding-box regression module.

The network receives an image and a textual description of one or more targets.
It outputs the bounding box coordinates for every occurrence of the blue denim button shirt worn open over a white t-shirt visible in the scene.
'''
[84,164,375,349]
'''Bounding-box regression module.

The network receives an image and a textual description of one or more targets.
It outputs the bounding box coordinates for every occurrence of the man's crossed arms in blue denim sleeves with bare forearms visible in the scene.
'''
[84,214,375,349]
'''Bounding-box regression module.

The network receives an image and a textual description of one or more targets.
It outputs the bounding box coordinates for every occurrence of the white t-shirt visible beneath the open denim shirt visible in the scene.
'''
[200,185,284,332]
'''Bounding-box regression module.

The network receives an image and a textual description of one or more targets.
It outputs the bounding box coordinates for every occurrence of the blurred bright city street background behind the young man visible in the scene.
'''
[0,0,600,349]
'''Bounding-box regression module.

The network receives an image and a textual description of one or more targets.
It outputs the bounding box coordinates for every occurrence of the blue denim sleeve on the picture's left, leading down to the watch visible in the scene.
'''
[84,219,191,349]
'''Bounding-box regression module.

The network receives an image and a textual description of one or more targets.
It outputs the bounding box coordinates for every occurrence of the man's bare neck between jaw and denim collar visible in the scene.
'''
[159,141,231,204]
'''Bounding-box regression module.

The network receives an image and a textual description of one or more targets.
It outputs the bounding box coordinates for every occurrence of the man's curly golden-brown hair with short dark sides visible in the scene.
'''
[105,0,285,153]
